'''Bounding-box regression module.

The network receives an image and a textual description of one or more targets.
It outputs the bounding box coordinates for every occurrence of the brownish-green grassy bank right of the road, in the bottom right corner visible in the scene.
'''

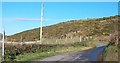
[103,45,119,61]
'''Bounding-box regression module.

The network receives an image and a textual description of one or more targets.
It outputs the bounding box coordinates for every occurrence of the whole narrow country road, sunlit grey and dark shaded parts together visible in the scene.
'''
[40,43,106,62]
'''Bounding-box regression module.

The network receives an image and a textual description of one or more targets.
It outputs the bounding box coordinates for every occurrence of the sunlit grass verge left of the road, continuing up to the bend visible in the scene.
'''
[15,41,94,61]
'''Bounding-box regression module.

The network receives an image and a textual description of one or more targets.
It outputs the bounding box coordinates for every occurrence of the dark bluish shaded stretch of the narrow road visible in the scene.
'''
[74,46,106,61]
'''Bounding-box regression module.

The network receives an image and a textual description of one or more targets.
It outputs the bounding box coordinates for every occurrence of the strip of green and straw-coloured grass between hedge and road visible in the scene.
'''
[15,42,90,61]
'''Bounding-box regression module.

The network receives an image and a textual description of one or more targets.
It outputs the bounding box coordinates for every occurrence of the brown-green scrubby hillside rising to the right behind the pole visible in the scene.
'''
[7,16,118,42]
